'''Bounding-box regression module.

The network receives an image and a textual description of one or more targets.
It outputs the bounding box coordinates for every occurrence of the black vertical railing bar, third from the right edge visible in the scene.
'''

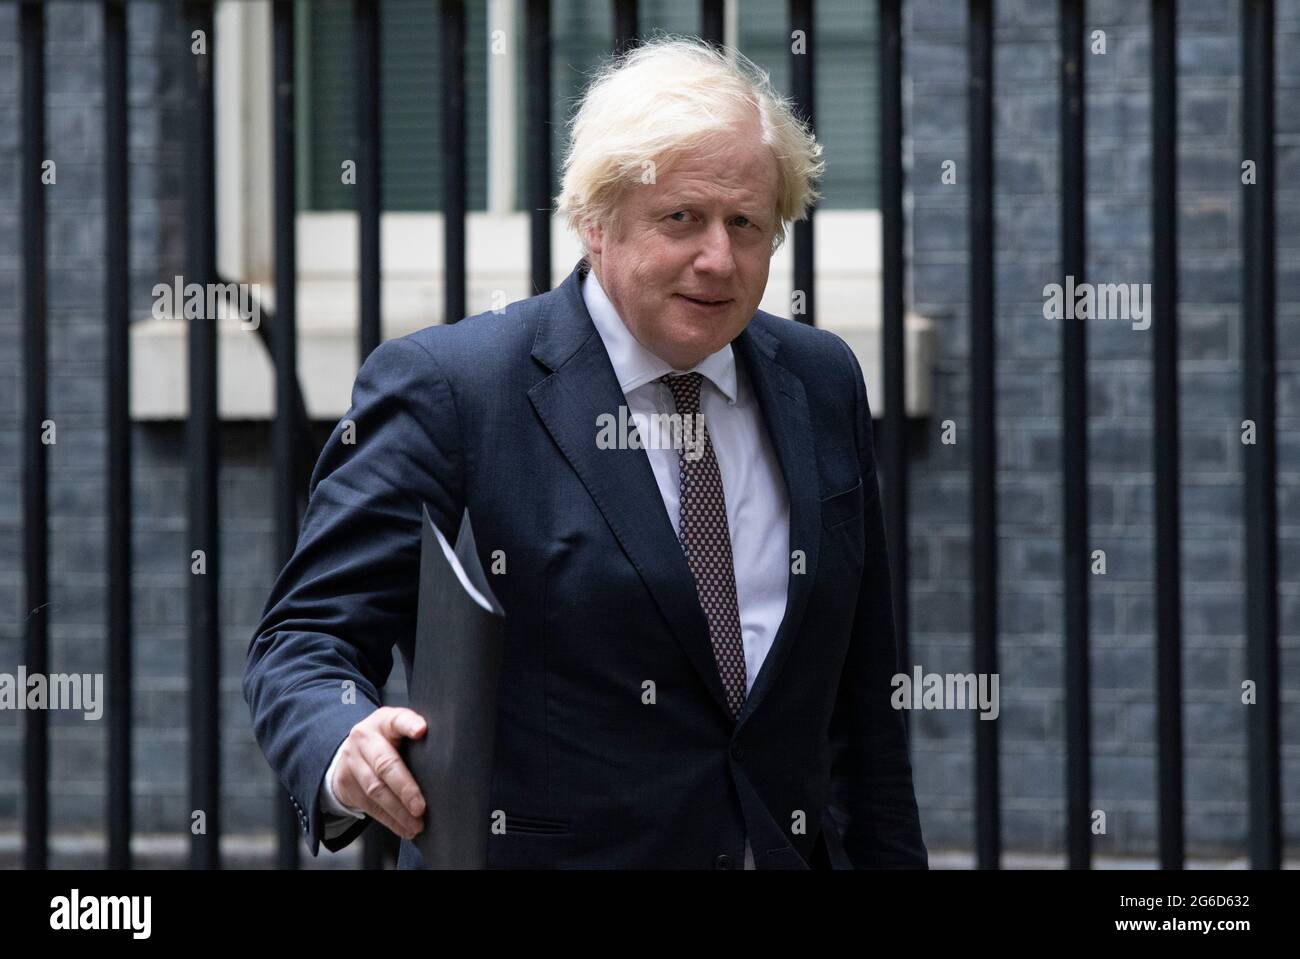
[1060,0,1092,869]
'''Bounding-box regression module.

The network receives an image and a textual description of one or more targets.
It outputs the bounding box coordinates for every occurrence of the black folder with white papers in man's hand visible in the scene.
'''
[402,507,506,869]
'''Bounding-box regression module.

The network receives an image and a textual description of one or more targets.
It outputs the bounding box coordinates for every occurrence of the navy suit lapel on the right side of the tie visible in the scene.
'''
[732,317,822,725]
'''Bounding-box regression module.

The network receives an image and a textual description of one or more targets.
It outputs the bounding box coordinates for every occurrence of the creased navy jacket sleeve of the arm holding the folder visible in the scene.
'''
[243,338,464,855]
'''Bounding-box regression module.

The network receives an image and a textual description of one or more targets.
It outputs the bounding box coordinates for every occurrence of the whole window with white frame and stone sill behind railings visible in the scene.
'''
[131,0,932,420]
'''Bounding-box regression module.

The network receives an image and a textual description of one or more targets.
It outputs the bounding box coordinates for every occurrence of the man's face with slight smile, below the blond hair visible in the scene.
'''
[586,121,777,369]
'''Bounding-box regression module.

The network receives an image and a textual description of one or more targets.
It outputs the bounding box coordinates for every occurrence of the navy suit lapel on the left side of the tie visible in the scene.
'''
[528,261,727,710]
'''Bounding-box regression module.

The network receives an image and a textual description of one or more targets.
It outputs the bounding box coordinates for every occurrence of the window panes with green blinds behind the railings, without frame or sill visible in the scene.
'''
[298,0,879,212]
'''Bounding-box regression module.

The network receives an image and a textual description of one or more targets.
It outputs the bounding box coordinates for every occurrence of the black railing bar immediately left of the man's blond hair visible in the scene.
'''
[524,0,554,295]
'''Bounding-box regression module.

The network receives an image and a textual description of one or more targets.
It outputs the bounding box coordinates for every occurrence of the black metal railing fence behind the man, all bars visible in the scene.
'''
[12,0,1282,869]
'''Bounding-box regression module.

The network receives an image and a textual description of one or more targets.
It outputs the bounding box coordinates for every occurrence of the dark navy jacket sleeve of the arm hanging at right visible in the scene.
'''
[829,340,930,869]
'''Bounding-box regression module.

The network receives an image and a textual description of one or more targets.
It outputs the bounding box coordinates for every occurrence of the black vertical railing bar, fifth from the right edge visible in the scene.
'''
[879,0,911,717]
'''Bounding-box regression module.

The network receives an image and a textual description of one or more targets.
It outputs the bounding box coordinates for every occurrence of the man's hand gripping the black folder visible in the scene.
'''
[330,706,429,839]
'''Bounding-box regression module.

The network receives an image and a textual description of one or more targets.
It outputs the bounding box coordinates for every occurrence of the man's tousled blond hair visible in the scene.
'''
[555,35,826,252]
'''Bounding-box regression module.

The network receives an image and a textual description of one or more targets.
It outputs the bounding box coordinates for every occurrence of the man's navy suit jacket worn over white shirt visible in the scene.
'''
[244,260,927,869]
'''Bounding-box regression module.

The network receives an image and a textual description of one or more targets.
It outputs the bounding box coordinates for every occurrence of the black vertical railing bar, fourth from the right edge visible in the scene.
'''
[967,0,1002,869]
